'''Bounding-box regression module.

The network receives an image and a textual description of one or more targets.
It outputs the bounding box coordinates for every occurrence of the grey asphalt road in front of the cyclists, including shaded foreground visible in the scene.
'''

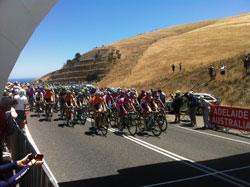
[25,113,250,187]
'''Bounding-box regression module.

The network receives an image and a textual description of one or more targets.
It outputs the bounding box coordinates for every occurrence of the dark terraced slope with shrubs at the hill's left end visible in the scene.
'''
[38,47,121,82]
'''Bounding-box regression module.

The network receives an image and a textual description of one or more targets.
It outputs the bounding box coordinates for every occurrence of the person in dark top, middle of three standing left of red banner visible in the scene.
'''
[184,91,198,126]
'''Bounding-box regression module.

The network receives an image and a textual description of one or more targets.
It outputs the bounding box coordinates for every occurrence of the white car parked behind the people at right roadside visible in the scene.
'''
[166,93,221,115]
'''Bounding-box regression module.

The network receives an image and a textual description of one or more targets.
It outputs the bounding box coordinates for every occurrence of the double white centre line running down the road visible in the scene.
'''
[109,128,250,186]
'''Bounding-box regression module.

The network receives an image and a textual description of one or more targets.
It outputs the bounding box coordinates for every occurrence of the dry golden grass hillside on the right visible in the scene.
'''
[98,13,250,107]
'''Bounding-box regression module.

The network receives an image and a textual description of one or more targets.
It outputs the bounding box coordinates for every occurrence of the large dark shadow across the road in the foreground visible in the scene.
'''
[59,153,250,187]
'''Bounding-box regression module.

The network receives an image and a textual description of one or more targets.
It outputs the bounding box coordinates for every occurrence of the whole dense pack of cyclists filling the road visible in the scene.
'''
[4,82,170,136]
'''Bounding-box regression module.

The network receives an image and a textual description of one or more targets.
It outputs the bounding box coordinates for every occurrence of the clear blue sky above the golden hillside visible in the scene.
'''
[10,0,250,78]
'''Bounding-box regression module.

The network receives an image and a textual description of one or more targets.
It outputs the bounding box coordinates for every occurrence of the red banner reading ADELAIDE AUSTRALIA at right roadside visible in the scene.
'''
[210,105,250,131]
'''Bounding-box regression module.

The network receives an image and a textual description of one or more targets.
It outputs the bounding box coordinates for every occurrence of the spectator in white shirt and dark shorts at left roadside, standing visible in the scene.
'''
[14,89,28,129]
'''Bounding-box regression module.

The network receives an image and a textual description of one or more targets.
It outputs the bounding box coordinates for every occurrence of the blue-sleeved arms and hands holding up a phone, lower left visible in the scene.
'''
[0,153,43,187]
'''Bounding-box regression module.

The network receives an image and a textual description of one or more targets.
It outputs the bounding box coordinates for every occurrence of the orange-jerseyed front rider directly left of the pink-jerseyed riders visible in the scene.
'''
[91,92,107,125]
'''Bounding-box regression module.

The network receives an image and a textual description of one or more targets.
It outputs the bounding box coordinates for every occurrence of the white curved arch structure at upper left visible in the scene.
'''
[0,0,58,96]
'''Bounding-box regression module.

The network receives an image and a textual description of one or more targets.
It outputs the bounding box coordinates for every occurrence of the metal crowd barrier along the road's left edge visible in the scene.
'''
[8,129,59,187]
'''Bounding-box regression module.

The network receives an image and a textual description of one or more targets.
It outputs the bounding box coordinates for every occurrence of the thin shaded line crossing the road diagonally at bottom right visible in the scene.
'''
[143,166,250,187]
